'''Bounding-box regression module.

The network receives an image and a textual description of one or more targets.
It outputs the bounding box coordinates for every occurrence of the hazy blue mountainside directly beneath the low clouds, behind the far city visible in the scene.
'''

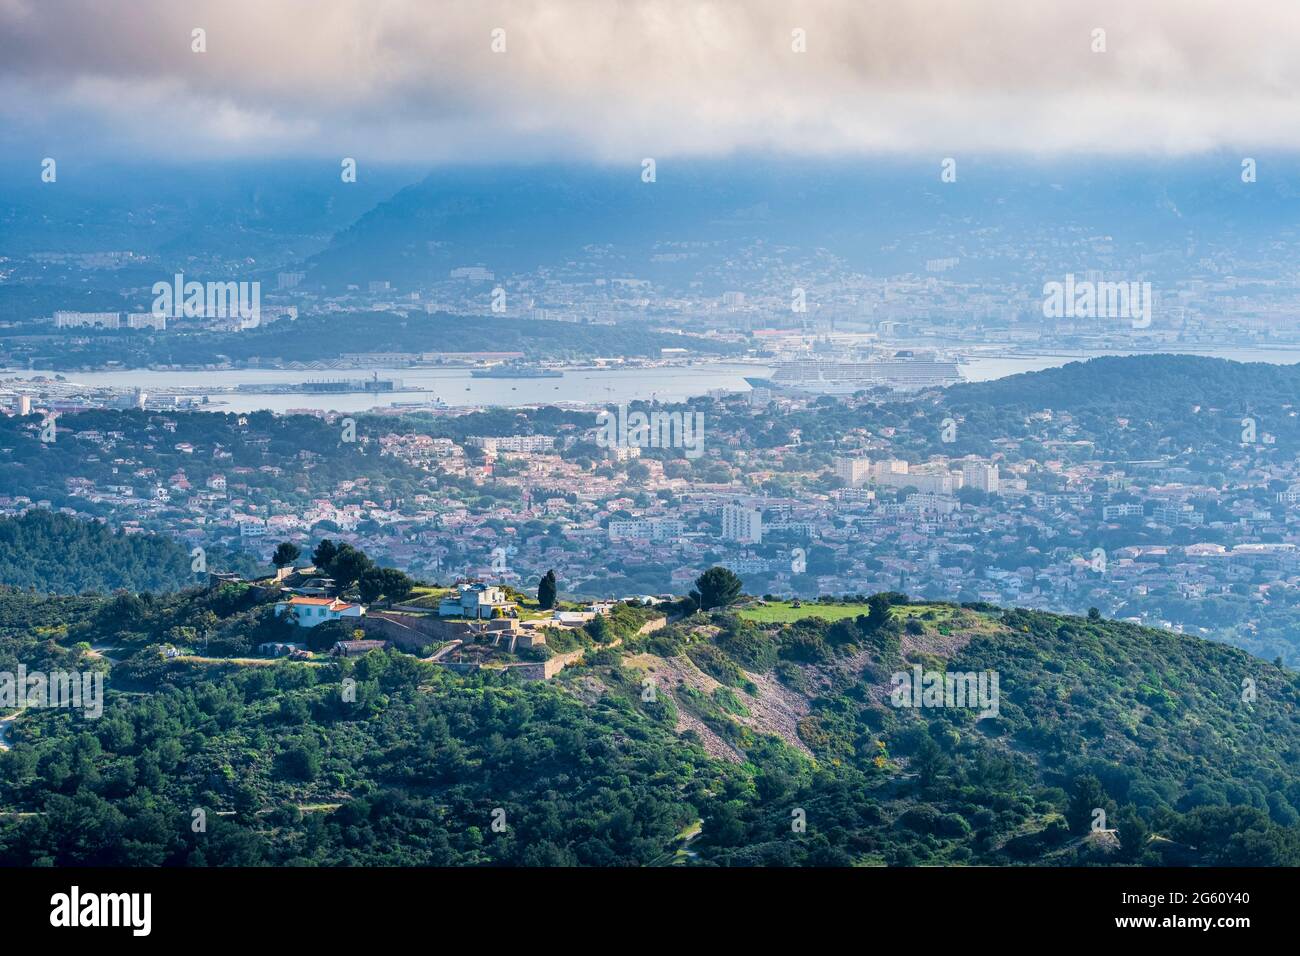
[306,156,1300,295]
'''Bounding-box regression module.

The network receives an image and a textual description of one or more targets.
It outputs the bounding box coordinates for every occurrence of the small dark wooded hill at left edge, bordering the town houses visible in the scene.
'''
[0,510,252,594]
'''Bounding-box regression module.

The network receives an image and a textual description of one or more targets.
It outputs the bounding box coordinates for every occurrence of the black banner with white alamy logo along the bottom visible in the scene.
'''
[0,868,1279,946]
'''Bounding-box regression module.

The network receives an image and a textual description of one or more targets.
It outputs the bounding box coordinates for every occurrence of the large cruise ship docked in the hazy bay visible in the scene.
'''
[746,350,962,395]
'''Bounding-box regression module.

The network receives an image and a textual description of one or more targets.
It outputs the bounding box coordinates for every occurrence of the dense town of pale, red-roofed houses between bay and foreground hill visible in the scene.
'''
[0,369,1300,660]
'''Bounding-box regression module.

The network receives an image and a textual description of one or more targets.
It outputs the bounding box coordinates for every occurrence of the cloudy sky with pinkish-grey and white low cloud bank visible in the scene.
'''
[0,0,1300,163]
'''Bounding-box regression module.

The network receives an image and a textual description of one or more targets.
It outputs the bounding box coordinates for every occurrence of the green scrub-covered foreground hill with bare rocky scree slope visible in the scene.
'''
[0,585,1300,865]
